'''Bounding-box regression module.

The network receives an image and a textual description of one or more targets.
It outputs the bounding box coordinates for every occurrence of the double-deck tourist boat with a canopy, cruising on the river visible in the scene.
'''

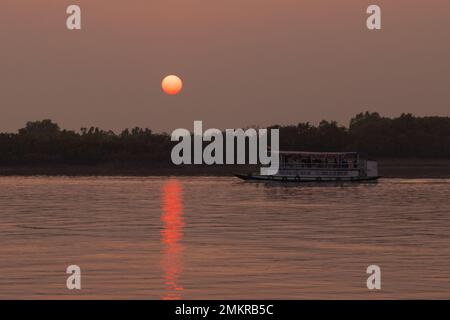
[235,151,379,182]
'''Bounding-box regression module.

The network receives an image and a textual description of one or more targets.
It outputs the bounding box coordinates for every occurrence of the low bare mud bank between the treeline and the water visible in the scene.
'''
[0,159,450,178]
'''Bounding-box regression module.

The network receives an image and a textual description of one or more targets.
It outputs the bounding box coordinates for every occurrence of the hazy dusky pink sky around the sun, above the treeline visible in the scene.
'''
[0,0,450,132]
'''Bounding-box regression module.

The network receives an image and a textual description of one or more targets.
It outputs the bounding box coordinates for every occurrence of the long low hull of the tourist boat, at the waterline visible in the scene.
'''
[234,174,380,183]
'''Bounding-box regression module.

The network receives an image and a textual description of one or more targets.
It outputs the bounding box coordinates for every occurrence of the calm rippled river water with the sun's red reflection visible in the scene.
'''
[0,177,450,299]
